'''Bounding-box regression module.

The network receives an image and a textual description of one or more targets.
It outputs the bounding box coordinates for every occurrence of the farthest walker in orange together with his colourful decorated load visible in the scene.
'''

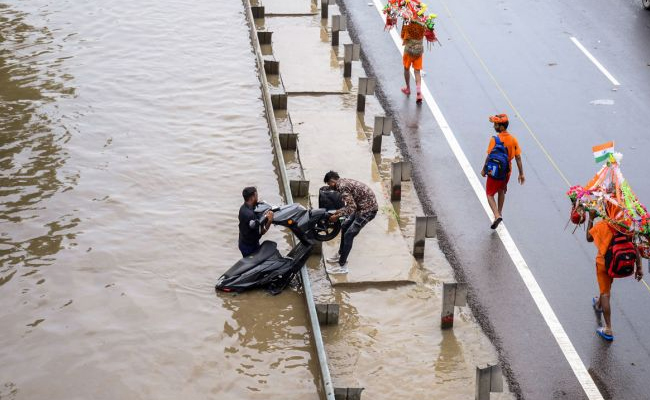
[384,0,438,104]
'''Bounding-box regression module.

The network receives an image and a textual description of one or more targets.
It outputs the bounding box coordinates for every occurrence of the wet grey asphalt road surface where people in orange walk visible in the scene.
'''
[336,0,650,400]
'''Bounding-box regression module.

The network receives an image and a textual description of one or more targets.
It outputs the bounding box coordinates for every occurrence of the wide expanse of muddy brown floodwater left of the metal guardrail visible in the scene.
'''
[0,0,318,399]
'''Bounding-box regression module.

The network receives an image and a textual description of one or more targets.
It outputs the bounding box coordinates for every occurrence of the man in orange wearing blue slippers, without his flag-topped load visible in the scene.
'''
[587,205,643,342]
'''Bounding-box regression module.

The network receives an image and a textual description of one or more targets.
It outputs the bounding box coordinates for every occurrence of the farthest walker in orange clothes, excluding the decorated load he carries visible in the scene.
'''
[402,21,425,104]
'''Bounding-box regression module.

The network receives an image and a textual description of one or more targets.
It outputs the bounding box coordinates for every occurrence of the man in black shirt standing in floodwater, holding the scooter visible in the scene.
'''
[239,186,273,257]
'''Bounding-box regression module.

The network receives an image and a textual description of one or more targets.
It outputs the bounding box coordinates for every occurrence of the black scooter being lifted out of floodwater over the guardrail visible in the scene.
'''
[215,190,342,294]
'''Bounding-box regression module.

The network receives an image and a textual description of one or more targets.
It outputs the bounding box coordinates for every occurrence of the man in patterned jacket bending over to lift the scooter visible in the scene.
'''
[323,171,379,274]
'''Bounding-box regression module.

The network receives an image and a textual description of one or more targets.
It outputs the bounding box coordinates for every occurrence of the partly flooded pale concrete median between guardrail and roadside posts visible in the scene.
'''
[256,0,512,400]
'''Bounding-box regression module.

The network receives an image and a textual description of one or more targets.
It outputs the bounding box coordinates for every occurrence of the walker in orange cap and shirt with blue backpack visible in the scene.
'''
[481,114,526,229]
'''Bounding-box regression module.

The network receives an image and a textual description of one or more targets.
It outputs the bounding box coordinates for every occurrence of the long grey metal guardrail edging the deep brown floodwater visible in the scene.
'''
[242,0,334,400]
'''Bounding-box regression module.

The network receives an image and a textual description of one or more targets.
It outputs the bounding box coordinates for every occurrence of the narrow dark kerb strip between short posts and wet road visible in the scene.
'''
[337,0,523,400]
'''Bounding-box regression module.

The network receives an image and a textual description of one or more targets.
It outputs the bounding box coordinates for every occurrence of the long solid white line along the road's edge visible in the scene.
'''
[373,0,604,400]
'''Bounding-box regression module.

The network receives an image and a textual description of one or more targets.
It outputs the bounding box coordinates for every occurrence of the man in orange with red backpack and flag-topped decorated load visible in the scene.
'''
[567,141,650,341]
